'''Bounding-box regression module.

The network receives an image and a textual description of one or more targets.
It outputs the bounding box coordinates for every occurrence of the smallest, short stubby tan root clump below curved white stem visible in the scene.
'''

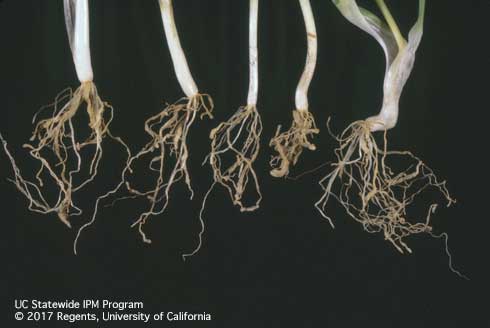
[269,110,319,178]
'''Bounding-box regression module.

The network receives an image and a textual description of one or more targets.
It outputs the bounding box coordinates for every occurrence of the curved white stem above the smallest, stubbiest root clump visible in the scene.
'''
[296,0,318,111]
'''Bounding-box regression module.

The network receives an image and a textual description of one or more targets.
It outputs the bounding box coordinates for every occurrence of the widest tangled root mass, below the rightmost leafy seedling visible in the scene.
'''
[315,121,455,253]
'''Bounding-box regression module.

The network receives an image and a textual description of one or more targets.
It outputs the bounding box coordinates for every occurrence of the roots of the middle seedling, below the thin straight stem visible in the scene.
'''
[206,105,262,212]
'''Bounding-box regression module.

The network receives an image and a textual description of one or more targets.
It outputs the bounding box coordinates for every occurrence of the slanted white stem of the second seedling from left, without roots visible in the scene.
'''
[159,0,198,98]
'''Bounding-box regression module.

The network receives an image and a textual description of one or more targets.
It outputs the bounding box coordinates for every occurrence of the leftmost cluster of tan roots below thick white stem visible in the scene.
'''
[2,82,123,226]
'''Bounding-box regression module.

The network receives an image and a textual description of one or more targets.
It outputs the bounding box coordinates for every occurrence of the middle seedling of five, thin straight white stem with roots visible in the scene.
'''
[206,0,262,212]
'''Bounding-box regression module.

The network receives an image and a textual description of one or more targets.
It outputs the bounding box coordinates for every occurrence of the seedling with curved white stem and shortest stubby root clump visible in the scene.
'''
[270,0,319,178]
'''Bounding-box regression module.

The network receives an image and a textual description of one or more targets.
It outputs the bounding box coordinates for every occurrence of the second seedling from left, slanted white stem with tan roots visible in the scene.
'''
[74,0,213,252]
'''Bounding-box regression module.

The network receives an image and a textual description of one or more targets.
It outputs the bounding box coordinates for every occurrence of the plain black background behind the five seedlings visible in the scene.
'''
[0,0,490,327]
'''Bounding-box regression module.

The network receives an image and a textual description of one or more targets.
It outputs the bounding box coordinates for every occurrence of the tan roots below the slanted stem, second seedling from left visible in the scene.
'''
[123,94,213,243]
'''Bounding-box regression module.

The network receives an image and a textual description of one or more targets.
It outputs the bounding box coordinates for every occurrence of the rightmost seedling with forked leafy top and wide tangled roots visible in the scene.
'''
[316,0,462,272]
